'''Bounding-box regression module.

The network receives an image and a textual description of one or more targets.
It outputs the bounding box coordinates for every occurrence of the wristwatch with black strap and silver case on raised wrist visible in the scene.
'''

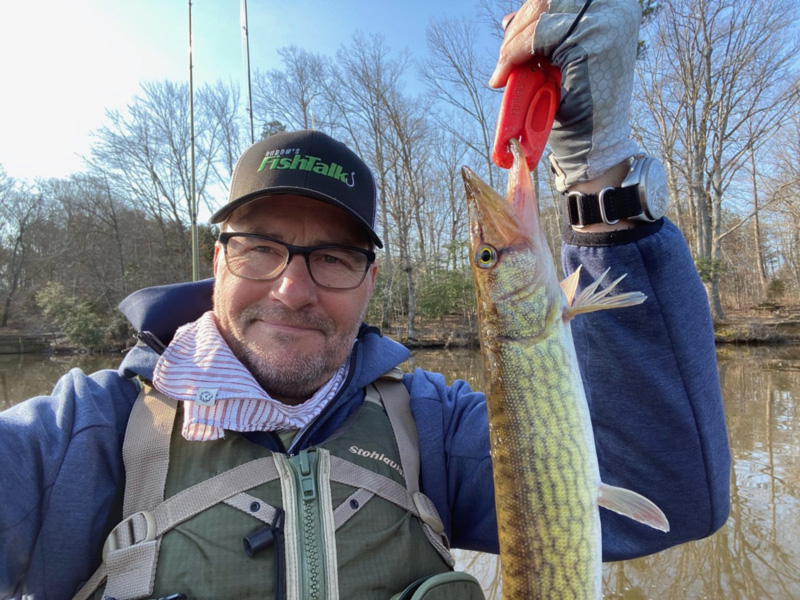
[566,155,669,228]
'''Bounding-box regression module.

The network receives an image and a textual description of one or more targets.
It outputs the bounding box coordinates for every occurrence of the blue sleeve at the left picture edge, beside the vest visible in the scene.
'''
[0,369,137,599]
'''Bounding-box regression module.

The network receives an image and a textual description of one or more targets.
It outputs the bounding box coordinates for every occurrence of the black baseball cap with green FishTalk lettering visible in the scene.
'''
[210,129,383,248]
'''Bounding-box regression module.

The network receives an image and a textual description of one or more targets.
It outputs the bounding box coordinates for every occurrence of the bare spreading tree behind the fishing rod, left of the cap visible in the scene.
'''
[90,81,231,270]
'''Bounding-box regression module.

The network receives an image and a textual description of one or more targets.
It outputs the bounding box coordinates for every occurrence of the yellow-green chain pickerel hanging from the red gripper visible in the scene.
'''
[462,140,669,600]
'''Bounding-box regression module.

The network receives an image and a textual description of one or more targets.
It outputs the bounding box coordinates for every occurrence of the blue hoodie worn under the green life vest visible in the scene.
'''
[0,220,730,600]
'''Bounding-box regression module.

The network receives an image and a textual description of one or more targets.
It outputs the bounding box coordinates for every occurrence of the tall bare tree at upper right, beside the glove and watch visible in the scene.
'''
[640,0,798,319]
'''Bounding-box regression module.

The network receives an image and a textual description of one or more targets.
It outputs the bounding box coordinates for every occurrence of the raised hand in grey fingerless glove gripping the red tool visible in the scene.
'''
[489,0,641,190]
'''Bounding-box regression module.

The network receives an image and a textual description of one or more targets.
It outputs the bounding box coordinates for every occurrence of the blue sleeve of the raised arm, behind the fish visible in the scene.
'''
[562,219,731,560]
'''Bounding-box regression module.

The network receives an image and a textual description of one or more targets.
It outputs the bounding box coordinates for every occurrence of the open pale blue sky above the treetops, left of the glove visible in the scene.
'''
[0,0,490,181]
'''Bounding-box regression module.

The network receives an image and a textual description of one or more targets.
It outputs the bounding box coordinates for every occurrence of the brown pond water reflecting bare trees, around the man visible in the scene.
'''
[0,348,800,600]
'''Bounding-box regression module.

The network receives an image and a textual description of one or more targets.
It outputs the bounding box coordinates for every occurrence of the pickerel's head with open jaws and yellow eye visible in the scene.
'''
[461,139,566,337]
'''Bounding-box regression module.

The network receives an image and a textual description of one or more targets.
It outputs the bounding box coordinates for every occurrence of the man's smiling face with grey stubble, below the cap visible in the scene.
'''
[214,196,376,404]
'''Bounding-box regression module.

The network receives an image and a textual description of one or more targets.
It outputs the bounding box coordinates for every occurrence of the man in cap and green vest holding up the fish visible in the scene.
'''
[0,0,730,599]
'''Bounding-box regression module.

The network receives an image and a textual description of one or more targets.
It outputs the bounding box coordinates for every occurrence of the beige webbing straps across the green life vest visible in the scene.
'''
[74,369,455,600]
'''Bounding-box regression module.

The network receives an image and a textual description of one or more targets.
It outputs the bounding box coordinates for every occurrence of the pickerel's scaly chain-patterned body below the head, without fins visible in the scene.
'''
[484,270,600,598]
